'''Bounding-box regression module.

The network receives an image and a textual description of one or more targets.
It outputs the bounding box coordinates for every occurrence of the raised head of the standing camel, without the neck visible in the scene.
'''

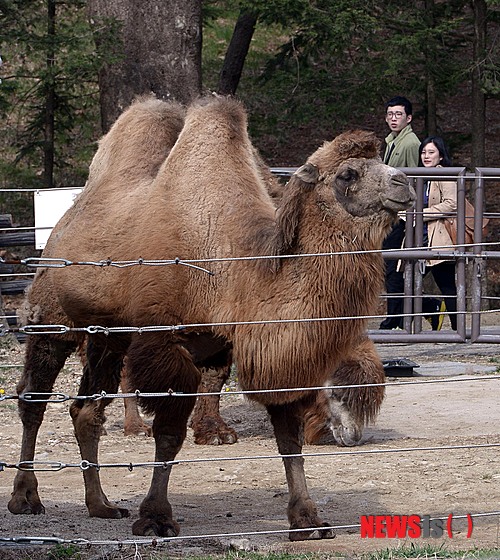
[296,130,415,221]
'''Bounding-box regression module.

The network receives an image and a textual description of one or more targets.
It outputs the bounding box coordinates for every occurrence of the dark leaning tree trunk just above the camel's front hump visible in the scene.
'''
[217,12,257,95]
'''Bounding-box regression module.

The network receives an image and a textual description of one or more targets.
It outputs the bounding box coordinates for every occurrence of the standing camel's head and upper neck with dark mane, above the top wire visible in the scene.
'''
[277,130,416,252]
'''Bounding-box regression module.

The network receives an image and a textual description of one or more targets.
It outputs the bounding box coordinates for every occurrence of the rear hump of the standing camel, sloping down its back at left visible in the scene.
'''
[44,96,185,259]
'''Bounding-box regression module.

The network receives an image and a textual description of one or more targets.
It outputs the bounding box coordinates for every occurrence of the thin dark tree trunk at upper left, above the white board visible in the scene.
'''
[43,0,56,188]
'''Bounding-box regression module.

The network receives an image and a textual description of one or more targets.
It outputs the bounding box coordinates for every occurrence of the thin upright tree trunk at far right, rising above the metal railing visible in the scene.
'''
[471,0,487,167]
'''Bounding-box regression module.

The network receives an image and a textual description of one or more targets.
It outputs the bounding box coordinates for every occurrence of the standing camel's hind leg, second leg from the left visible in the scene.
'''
[70,337,129,519]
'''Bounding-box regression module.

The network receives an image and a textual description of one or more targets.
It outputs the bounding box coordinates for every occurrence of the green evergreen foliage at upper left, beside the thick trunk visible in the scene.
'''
[0,0,112,187]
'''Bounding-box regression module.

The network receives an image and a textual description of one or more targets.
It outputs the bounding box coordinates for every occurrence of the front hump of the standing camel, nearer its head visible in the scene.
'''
[154,97,275,256]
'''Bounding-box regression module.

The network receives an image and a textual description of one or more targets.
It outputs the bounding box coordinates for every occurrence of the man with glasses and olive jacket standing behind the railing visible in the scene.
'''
[380,95,420,329]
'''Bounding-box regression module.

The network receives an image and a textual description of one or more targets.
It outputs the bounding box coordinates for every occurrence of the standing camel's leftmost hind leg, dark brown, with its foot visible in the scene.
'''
[7,335,77,515]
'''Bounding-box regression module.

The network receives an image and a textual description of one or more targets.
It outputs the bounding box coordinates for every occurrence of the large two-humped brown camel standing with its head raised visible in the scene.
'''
[9,98,414,540]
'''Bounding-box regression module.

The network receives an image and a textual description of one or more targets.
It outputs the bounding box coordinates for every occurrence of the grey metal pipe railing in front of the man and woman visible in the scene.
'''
[272,167,500,343]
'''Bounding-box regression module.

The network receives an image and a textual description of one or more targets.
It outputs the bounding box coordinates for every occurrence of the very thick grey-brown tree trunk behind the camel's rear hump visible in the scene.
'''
[88,0,202,131]
